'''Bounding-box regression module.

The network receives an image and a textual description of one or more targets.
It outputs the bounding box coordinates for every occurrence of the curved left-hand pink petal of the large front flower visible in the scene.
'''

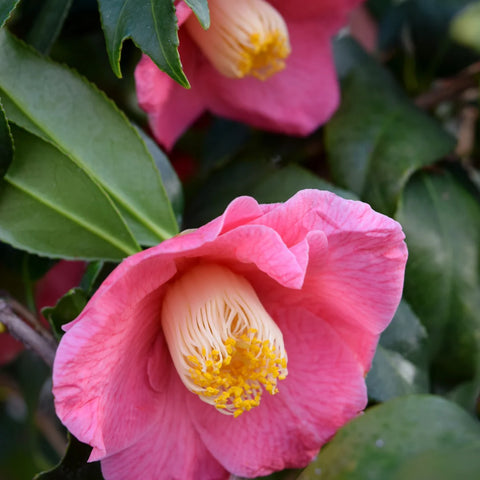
[53,254,179,459]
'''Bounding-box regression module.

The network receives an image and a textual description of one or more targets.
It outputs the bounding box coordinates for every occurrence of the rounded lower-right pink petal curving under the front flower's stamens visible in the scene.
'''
[188,305,367,477]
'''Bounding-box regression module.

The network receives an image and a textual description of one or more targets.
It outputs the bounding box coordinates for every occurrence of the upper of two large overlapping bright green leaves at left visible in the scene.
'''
[0,31,178,245]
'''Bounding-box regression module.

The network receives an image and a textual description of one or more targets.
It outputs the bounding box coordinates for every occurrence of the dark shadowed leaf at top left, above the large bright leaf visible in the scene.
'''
[26,0,73,55]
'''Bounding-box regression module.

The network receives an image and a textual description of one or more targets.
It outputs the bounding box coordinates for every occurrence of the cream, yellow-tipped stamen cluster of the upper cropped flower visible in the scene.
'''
[185,0,290,80]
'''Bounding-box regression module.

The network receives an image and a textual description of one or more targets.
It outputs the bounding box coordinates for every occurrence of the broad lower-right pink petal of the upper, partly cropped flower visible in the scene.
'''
[198,20,339,135]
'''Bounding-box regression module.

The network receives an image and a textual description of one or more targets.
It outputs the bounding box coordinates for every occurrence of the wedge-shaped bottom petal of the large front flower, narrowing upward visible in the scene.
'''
[102,375,229,480]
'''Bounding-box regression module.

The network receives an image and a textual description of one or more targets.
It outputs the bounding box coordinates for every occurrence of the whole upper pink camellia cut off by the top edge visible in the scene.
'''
[135,0,362,149]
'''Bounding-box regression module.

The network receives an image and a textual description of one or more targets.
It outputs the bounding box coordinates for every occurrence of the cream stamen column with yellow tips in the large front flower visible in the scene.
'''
[162,264,288,417]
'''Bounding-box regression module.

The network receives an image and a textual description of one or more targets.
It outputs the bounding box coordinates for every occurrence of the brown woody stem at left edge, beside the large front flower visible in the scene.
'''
[0,298,55,367]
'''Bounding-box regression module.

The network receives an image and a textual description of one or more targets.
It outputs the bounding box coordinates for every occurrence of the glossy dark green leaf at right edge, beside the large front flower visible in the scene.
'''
[396,171,480,381]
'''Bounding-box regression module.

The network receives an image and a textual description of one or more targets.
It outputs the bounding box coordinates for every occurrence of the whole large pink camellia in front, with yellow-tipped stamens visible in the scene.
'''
[53,190,407,480]
